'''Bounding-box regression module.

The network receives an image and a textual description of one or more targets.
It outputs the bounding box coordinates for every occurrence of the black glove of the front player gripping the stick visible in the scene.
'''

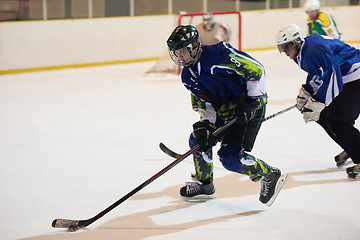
[193,121,216,152]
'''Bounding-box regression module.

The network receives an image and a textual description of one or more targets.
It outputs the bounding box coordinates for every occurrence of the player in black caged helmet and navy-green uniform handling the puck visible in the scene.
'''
[167,25,286,206]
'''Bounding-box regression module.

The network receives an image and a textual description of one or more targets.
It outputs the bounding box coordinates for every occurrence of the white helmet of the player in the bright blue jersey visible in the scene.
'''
[276,24,304,53]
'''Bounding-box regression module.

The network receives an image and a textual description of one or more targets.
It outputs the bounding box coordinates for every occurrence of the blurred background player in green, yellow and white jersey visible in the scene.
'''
[304,0,344,41]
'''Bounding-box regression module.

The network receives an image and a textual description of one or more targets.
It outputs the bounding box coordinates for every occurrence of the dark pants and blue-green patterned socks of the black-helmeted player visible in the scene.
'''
[189,107,271,184]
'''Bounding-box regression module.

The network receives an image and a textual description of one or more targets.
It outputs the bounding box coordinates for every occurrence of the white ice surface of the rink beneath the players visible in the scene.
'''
[0,47,360,240]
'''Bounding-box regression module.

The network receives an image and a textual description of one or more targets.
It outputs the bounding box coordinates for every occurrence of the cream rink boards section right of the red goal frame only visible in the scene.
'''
[242,6,360,50]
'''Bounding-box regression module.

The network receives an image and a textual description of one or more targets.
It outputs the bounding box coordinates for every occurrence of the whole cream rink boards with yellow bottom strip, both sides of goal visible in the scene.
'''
[0,6,360,74]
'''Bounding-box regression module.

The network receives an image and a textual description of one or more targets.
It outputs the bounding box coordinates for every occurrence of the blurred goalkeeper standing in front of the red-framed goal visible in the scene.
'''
[196,13,231,45]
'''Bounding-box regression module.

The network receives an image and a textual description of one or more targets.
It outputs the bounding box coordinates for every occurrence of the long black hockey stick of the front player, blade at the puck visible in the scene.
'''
[52,118,237,231]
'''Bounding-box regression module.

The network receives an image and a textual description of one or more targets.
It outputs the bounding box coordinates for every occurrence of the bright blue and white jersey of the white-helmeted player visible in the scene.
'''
[294,35,360,106]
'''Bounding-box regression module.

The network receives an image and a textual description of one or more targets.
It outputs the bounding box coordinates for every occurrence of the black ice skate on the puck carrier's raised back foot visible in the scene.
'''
[259,168,287,207]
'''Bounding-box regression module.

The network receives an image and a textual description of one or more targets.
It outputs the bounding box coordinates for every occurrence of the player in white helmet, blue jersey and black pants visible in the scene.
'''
[276,24,360,178]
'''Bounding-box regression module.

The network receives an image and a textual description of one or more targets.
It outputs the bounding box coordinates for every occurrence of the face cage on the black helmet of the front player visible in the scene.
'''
[169,43,201,67]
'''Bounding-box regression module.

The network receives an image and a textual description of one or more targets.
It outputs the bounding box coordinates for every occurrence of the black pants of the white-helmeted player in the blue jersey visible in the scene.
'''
[317,79,360,163]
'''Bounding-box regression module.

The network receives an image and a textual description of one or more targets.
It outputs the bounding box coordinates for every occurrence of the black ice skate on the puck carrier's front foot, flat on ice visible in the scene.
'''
[180,181,215,201]
